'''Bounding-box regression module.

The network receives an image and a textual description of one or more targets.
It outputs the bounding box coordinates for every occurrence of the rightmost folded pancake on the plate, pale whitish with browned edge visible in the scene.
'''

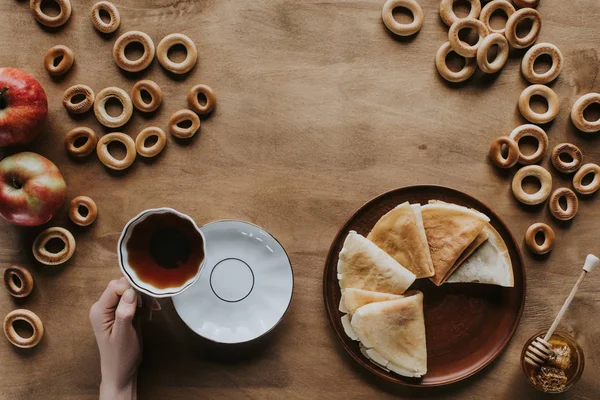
[446,224,515,287]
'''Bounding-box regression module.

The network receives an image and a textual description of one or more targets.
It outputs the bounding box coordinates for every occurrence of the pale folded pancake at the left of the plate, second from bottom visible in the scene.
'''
[337,231,415,294]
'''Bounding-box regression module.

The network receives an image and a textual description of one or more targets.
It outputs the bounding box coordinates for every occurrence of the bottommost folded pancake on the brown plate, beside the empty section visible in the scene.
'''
[351,291,427,377]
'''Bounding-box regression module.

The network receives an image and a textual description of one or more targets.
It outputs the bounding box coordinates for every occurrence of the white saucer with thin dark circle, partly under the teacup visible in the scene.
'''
[173,220,294,343]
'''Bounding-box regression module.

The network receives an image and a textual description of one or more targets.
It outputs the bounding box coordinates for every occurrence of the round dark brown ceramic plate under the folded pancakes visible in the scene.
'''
[323,186,525,387]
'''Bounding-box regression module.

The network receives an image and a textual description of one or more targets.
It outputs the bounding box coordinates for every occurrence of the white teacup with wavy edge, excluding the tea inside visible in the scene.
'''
[117,207,206,298]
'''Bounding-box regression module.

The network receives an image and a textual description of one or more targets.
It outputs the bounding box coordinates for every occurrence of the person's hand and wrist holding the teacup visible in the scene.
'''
[90,278,142,400]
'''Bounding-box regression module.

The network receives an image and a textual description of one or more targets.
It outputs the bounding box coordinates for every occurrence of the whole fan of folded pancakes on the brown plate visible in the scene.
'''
[338,200,514,377]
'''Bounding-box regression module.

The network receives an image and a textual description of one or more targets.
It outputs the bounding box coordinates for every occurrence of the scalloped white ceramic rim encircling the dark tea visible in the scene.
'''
[117,207,207,298]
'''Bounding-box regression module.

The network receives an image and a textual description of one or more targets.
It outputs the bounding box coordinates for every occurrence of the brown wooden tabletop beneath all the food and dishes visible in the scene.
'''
[0,0,600,399]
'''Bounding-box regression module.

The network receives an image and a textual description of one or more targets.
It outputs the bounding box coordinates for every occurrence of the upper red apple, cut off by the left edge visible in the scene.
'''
[0,68,48,147]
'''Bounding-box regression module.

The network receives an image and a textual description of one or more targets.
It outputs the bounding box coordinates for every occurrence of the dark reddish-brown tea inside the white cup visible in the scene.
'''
[127,213,204,289]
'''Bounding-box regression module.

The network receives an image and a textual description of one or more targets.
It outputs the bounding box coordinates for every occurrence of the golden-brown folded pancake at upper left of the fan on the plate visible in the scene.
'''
[367,202,434,279]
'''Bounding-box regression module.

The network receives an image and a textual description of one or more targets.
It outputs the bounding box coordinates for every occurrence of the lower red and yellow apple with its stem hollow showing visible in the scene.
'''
[0,152,67,226]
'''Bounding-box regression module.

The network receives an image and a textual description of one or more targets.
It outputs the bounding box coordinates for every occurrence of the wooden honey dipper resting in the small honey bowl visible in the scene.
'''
[525,254,600,367]
